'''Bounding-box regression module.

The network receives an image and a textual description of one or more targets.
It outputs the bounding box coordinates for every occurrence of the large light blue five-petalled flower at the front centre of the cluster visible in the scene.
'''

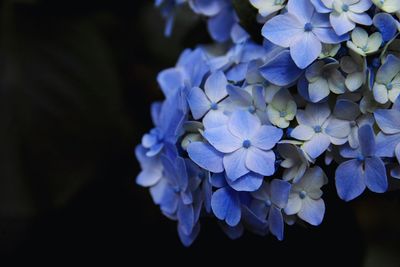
[204,110,282,191]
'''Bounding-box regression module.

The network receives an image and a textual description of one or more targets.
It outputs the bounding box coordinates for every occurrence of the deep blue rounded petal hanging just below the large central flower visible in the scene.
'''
[211,187,241,226]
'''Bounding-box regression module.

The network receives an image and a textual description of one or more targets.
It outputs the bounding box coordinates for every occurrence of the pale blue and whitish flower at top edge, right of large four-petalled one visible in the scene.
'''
[312,0,372,35]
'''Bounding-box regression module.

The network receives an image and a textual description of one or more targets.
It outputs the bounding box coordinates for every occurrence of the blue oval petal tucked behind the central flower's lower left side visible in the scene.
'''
[187,142,224,173]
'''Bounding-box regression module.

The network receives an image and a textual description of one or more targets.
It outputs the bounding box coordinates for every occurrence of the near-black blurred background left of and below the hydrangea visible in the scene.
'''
[0,0,400,266]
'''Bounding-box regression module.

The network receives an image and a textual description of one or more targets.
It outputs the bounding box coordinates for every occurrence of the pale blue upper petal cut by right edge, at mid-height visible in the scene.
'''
[374,109,400,134]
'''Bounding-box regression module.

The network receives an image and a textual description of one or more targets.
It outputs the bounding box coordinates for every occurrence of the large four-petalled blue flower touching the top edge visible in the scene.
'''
[262,0,348,69]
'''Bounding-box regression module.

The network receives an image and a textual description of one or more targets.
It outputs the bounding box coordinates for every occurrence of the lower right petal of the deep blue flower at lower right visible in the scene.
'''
[365,157,388,193]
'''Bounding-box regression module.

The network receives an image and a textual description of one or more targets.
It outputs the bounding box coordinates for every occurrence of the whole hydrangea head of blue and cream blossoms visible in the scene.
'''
[136,0,400,246]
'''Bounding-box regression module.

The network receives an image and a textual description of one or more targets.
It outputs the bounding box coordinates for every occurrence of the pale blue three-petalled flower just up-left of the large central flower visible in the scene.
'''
[187,71,228,128]
